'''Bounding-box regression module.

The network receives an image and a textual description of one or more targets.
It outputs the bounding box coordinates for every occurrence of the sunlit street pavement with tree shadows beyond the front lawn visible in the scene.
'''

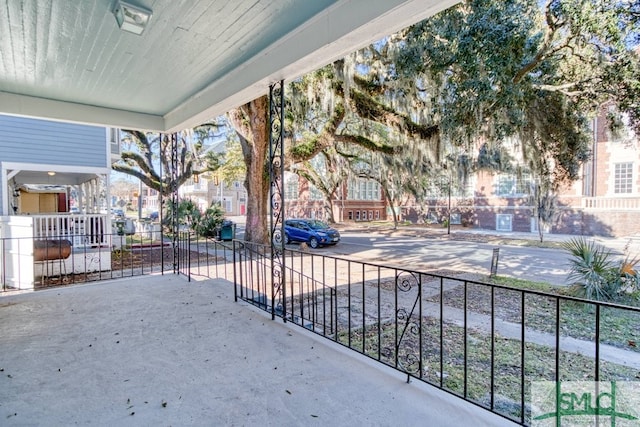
[229,217,640,286]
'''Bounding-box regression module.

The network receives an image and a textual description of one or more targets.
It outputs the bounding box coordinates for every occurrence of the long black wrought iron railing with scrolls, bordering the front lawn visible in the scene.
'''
[228,242,640,425]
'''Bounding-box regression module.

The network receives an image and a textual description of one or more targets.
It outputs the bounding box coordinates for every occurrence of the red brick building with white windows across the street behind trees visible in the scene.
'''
[285,107,640,237]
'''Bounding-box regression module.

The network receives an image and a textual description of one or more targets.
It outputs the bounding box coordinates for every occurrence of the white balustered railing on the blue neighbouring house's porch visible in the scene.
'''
[30,214,111,247]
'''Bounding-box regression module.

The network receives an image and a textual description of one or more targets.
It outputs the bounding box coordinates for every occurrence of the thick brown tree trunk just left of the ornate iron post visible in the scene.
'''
[229,95,270,244]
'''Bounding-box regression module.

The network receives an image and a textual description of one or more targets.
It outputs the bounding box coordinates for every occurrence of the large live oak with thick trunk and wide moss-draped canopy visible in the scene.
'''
[231,0,640,242]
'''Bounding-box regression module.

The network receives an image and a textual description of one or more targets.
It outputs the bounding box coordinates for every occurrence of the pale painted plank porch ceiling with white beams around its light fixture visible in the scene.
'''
[0,0,457,131]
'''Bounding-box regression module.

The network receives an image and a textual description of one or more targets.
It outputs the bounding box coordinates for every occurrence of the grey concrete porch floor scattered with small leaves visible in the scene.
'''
[0,274,514,426]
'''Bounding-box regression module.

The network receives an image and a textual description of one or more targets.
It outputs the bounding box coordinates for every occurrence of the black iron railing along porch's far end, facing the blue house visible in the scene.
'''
[0,233,233,292]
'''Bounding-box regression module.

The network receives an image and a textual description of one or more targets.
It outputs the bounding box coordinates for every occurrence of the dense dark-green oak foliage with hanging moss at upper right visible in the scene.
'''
[392,0,640,188]
